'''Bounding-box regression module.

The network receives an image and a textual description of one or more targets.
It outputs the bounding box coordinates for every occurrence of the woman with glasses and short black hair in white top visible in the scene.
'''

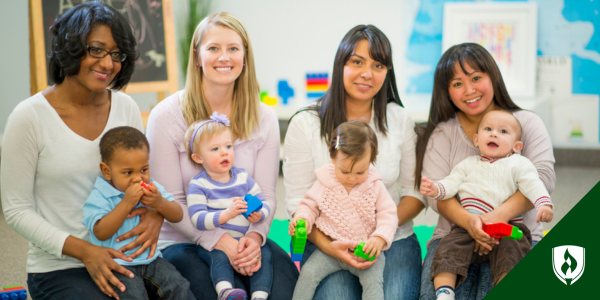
[1,2,184,299]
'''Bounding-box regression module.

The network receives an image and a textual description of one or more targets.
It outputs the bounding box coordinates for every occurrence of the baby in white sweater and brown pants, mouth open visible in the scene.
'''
[421,110,554,299]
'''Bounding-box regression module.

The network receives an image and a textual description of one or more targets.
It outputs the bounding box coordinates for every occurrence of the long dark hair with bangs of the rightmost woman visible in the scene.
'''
[415,43,521,189]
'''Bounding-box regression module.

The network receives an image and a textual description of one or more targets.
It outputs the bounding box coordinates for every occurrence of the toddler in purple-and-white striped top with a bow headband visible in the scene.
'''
[185,112,273,300]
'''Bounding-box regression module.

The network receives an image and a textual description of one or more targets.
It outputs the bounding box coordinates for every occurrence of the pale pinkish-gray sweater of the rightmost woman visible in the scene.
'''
[421,111,556,243]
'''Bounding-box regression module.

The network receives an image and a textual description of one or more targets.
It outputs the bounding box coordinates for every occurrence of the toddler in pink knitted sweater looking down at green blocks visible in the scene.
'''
[289,121,398,300]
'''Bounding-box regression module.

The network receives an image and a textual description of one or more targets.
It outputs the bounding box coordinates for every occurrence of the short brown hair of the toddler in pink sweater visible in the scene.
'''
[329,120,378,167]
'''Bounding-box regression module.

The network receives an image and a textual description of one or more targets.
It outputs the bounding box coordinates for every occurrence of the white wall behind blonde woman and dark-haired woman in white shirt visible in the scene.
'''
[211,0,409,118]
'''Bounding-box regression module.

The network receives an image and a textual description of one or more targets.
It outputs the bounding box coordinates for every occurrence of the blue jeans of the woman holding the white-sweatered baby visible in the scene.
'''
[420,239,538,300]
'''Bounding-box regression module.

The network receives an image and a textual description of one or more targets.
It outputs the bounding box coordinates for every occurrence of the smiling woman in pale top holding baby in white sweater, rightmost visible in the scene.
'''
[414,43,556,300]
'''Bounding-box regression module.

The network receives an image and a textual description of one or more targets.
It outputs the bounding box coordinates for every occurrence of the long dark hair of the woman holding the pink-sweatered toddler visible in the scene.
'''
[290,25,402,141]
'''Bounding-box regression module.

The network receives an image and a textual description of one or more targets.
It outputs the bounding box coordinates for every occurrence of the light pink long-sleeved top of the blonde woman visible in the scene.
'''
[146,92,280,250]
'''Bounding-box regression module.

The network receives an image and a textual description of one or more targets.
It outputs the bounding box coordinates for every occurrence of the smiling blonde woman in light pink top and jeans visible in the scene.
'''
[147,12,298,299]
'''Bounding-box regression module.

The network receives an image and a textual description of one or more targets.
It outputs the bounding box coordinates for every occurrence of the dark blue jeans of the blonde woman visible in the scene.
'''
[162,239,299,300]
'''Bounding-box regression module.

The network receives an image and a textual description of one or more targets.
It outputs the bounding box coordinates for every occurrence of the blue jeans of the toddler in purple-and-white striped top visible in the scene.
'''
[196,245,273,294]
